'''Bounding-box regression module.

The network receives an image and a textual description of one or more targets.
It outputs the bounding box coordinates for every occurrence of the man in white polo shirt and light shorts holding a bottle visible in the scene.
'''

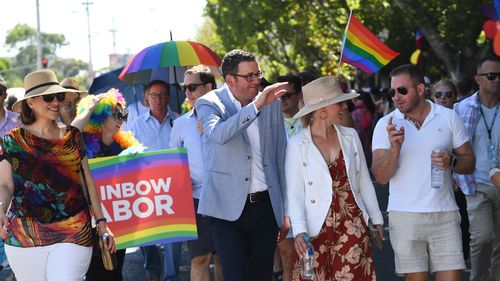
[372,65,475,280]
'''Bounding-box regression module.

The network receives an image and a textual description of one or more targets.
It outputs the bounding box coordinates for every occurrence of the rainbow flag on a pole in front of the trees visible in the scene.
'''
[340,13,399,73]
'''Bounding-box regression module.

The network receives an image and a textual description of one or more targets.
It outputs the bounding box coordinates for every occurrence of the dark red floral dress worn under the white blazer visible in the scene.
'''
[293,152,376,281]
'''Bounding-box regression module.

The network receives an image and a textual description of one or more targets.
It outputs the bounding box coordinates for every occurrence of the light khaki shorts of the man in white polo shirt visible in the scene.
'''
[389,211,465,274]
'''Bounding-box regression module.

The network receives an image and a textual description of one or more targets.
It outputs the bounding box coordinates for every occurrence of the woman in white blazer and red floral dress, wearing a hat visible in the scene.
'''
[285,76,383,280]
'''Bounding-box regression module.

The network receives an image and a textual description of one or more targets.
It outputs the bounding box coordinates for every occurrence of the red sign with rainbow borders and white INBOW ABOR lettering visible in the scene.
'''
[89,148,197,249]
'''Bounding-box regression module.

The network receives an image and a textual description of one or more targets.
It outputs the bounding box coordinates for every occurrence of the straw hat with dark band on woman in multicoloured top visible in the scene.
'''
[12,69,77,113]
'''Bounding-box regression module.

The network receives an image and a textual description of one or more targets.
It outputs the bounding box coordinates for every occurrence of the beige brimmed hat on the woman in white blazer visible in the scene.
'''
[293,76,359,118]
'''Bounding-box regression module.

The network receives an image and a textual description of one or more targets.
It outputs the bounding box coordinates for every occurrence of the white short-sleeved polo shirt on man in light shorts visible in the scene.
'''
[372,101,468,213]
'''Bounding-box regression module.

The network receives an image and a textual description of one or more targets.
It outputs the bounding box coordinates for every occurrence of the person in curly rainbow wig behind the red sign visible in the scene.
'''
[72,89,144,281]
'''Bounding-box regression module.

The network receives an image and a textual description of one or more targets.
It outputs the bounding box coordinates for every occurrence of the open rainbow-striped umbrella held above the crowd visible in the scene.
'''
[118,41,221,84]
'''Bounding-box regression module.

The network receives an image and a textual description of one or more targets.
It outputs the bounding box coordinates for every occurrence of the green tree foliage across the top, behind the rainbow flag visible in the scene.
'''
[206,0,491,82]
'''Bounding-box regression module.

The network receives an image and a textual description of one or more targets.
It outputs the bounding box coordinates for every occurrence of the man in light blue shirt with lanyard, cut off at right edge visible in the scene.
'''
[454,55,500,281]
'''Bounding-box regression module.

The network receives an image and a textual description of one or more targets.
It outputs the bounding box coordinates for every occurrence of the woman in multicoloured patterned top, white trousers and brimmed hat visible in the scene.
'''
[0,70,115,281]
